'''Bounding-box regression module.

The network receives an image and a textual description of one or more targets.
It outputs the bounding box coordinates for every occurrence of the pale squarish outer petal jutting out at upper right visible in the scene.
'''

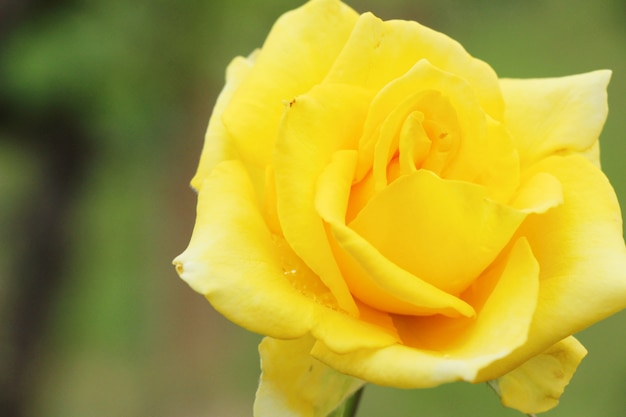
[500,71,611,166]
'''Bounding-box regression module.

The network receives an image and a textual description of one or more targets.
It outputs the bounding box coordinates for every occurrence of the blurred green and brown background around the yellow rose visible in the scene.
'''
[0,0,626,417]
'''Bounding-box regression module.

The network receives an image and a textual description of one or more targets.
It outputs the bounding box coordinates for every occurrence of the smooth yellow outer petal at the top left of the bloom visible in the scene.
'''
[223,0,358,166]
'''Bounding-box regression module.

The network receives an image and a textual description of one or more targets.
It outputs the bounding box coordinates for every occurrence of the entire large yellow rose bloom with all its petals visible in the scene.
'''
[174,0,626,417]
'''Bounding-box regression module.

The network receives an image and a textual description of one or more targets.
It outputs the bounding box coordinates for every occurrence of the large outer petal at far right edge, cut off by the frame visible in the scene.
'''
[472,155,626,379]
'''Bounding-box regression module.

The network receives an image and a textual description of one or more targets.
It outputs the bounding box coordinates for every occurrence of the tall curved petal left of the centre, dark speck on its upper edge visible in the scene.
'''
[274,84,371,315]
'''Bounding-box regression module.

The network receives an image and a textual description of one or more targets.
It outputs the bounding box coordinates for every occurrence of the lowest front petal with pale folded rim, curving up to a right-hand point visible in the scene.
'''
[312,239,539,388]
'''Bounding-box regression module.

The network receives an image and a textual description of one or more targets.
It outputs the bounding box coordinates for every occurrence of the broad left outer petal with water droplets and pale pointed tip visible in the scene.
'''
[174,161,397,352]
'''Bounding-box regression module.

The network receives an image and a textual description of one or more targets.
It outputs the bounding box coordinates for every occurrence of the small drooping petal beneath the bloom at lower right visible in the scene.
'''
[498,336,587,414]
